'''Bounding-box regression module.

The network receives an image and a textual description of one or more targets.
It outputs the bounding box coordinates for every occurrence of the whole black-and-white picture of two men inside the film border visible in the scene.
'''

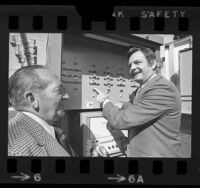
[8,32,193,158]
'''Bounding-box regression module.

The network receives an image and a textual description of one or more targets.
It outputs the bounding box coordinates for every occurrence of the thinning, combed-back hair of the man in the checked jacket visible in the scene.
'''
[8,65,48,108]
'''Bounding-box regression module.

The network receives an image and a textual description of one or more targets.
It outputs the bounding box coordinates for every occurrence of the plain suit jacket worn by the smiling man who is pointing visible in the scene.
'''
[103,75,181,157]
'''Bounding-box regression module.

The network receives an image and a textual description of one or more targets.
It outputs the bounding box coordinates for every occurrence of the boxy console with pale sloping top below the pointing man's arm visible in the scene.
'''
[80,112,128,157]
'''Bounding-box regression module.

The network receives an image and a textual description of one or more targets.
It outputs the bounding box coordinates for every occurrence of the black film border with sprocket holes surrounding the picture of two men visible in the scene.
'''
[0,6,200,185]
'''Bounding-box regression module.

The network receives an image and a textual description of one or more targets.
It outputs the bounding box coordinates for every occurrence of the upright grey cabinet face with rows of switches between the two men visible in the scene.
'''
[61,35,138,110]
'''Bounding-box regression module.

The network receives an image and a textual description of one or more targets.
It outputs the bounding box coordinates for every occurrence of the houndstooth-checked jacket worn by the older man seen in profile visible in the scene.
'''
[8,112,73,157]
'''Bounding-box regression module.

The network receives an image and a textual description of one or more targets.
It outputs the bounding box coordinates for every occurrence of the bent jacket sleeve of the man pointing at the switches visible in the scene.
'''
[103,87,176,129]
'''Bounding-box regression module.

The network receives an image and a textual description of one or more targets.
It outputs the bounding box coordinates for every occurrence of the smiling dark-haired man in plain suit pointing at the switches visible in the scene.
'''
[95,48,181,158]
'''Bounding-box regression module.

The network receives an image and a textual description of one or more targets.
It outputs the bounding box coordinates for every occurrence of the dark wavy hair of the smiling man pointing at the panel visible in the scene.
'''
[127,47,156,65]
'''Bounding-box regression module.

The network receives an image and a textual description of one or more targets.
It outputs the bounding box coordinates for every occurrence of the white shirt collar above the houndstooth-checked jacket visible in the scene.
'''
[22,112,56,138]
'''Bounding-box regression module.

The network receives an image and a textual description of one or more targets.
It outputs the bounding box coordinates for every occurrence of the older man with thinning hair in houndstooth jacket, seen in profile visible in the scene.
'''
[8,65,75,157]
